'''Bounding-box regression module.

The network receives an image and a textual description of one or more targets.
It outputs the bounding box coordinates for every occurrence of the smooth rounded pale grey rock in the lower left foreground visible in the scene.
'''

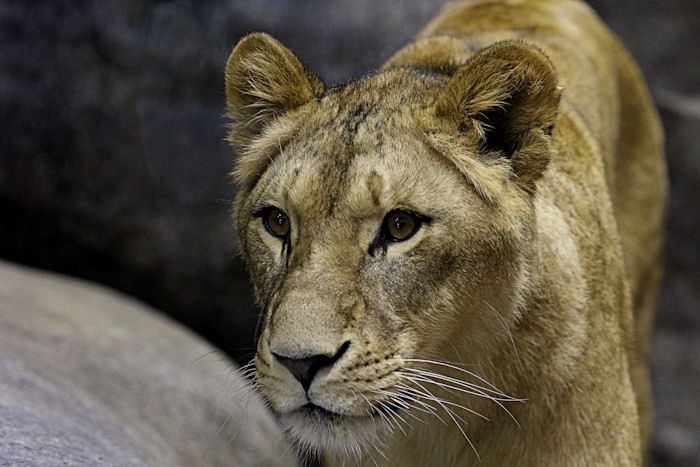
[0,262,295,467]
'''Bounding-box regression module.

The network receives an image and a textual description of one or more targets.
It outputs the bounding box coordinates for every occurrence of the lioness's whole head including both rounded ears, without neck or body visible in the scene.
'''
[226,34,560,464]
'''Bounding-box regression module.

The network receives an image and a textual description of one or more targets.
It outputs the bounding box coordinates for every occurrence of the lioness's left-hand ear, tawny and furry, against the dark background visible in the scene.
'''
[226,33,324,151]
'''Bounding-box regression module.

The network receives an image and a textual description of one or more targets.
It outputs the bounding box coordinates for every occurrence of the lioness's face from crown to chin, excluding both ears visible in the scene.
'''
[228,33,560,460]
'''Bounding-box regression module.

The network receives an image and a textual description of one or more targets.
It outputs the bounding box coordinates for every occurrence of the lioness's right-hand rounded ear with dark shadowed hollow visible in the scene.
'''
[438,40,561,189]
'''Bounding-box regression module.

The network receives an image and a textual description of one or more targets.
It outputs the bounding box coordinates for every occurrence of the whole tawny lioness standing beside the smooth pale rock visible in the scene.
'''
[226,0,666,466]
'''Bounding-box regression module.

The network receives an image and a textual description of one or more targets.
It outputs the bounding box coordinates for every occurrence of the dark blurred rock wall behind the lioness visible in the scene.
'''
[0,0,700,465]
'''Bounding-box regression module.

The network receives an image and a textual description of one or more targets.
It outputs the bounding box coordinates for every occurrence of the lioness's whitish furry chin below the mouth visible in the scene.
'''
[278,404,391,460]
